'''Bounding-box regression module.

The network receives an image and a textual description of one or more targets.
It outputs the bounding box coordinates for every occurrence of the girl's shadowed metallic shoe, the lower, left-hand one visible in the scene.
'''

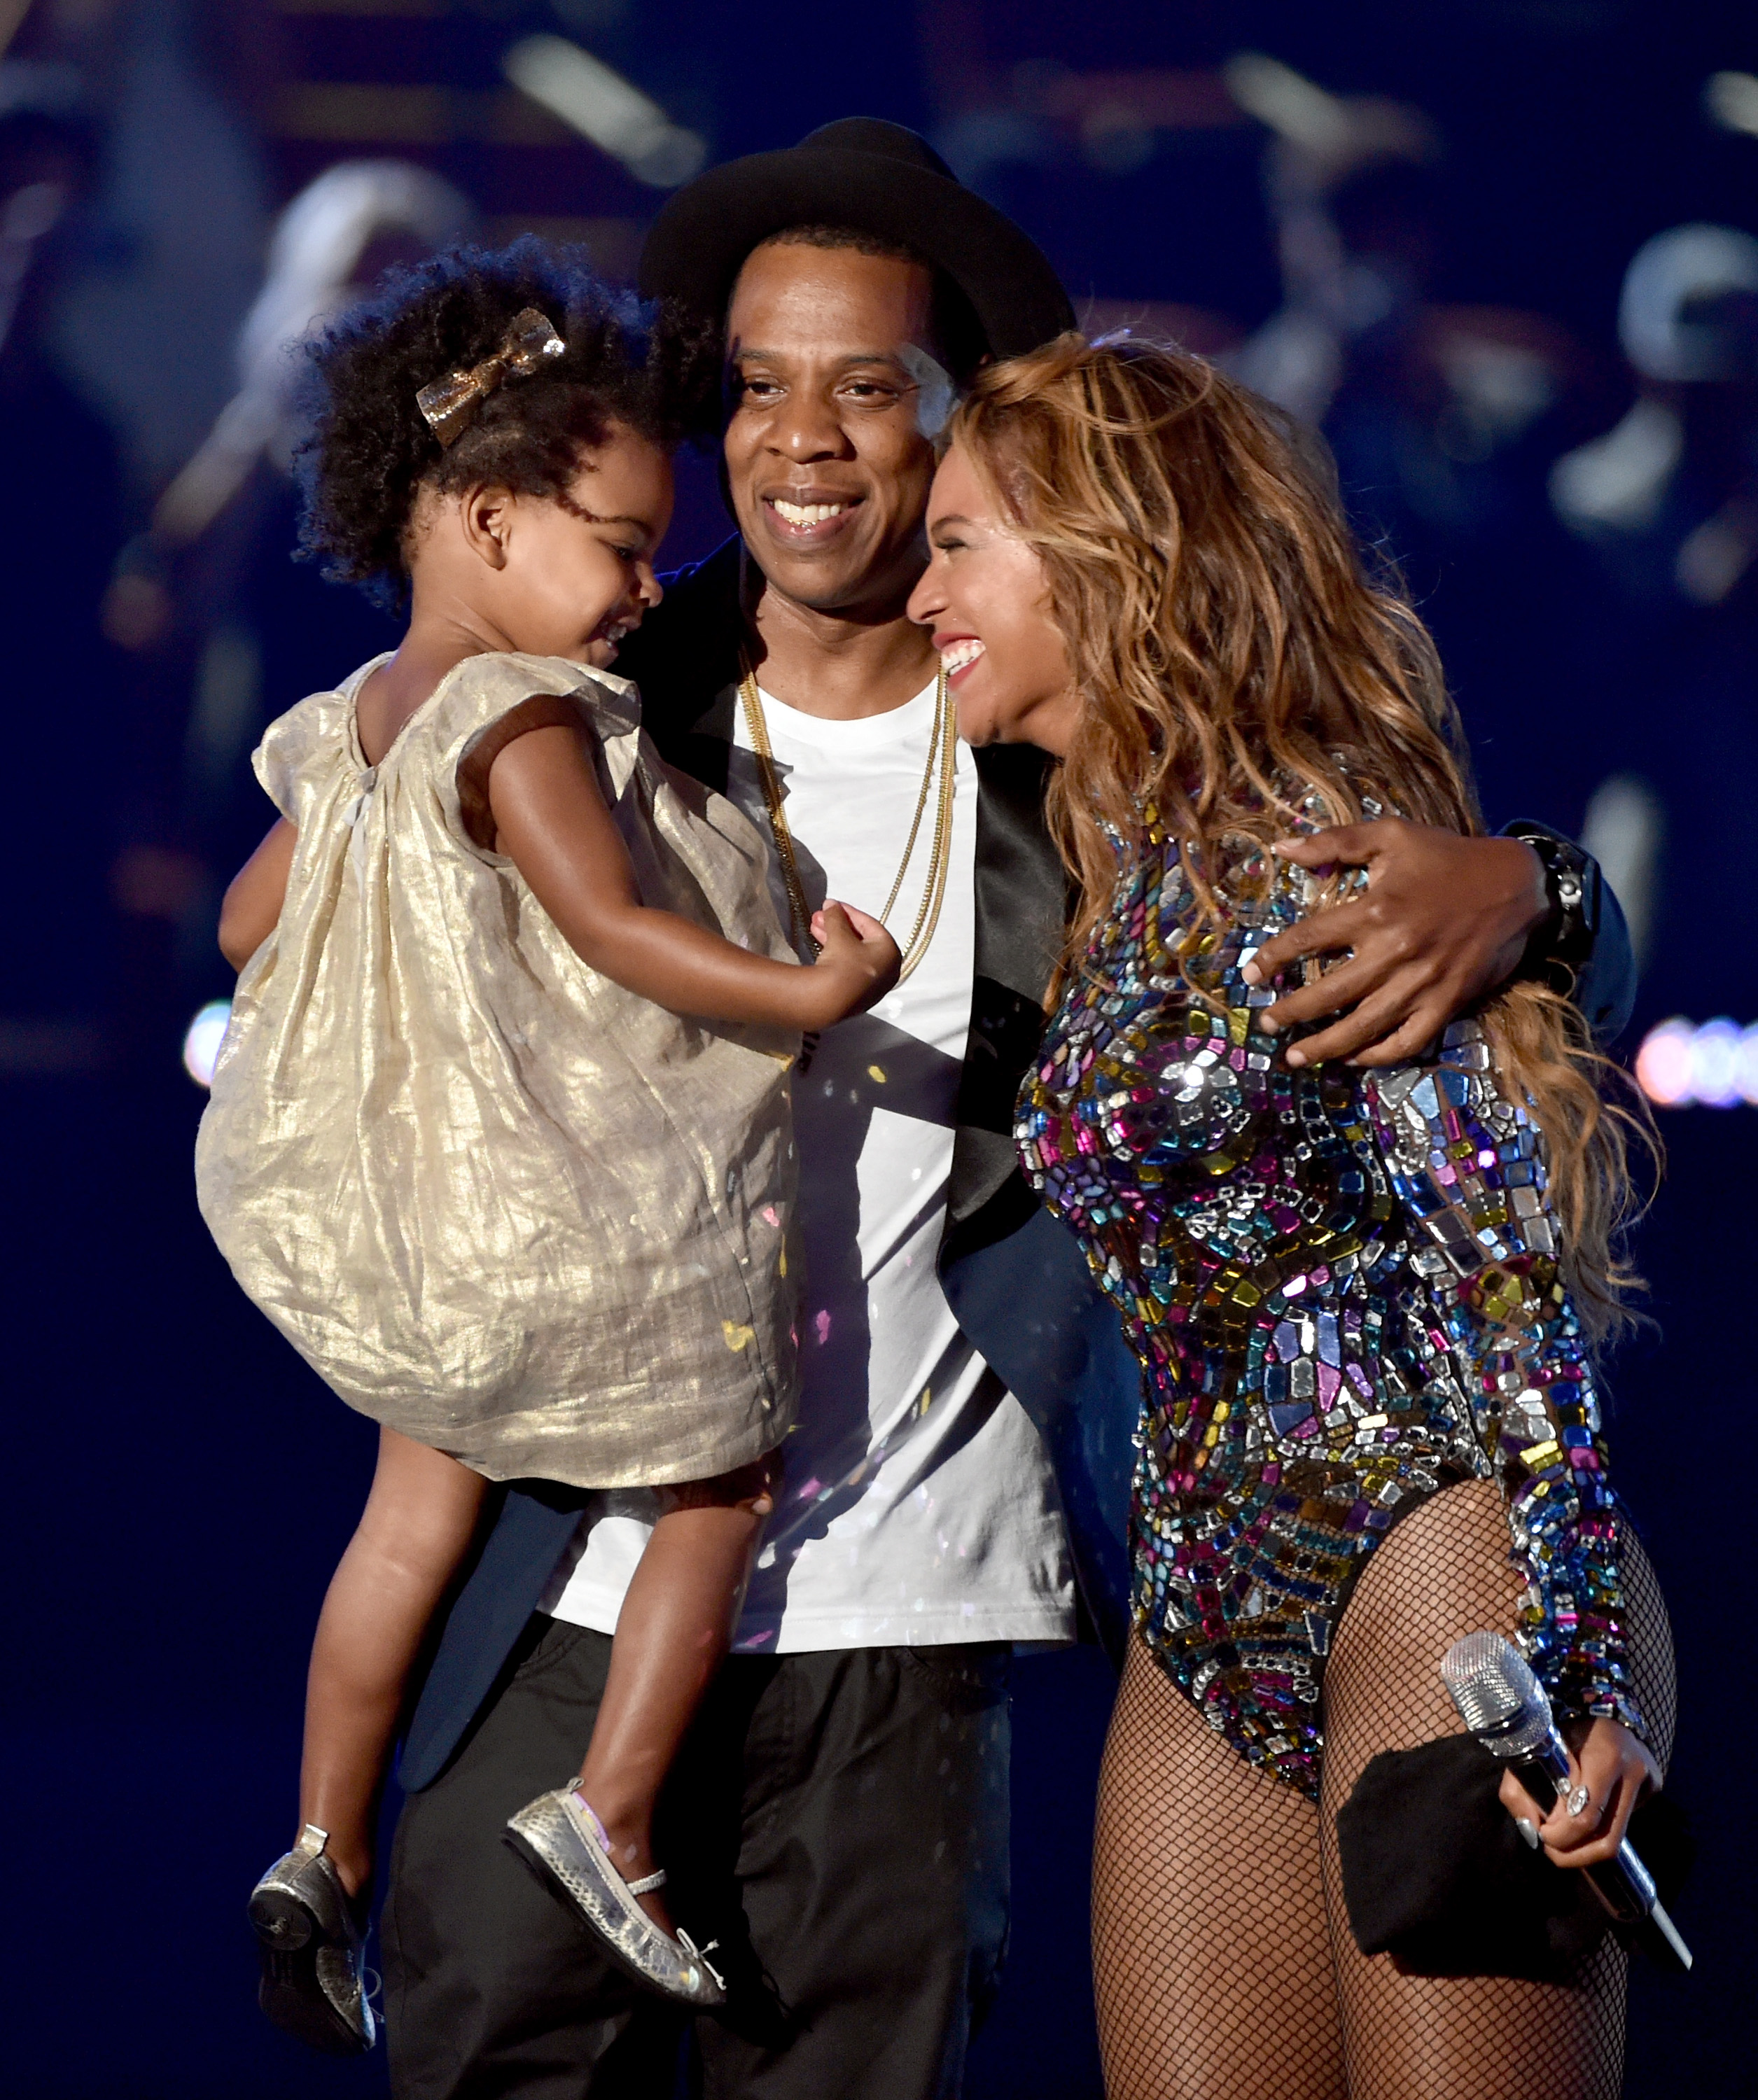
[250,1823,378,2056]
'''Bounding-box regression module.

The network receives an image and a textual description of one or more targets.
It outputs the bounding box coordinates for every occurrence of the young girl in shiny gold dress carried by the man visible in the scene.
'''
[197,241,897,2052]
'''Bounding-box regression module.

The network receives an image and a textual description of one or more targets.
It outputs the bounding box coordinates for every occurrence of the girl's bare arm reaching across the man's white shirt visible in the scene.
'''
[487,722,899,1031]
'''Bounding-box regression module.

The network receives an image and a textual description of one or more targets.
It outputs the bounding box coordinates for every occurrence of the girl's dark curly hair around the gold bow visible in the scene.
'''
[298,235,720,611]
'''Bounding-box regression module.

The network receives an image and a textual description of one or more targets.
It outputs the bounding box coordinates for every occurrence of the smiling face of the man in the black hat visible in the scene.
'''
[727,241,945,617]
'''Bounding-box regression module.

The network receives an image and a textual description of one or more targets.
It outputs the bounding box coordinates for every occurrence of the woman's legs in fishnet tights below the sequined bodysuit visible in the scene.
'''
[1092,1480,1676,2100]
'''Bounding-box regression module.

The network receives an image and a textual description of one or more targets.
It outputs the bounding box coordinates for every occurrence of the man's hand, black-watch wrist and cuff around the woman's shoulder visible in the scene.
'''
[1248,817,1634,1065]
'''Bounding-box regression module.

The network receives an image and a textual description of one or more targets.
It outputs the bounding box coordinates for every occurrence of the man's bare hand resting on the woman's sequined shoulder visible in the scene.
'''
[1246,817,1550,1065]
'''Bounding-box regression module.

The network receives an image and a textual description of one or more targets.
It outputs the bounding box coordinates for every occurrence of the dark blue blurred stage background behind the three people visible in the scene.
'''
[0,0,1758,2100]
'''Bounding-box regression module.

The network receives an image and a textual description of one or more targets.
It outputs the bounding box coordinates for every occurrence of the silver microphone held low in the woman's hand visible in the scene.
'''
[1441,1634,1691,1970]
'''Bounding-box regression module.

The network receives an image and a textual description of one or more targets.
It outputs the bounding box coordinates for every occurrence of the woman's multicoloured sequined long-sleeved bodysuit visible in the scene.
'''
[1017,825,1640,1793]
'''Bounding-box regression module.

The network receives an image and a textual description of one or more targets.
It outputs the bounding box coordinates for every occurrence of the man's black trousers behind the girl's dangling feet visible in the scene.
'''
[382,1617,1008,2100]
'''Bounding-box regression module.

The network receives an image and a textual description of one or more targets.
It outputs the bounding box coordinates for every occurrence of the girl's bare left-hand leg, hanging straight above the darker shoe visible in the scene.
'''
[298,1430,487,1896]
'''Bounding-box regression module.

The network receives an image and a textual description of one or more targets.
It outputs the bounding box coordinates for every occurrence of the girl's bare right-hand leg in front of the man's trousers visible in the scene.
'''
[578,1457,777,1930]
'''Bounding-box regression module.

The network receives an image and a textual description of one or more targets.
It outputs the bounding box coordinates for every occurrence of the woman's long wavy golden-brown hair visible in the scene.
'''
[945,334,1653,1334]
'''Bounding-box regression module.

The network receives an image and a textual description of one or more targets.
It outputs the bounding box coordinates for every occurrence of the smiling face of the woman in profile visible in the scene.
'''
[909,445,1080,758]
